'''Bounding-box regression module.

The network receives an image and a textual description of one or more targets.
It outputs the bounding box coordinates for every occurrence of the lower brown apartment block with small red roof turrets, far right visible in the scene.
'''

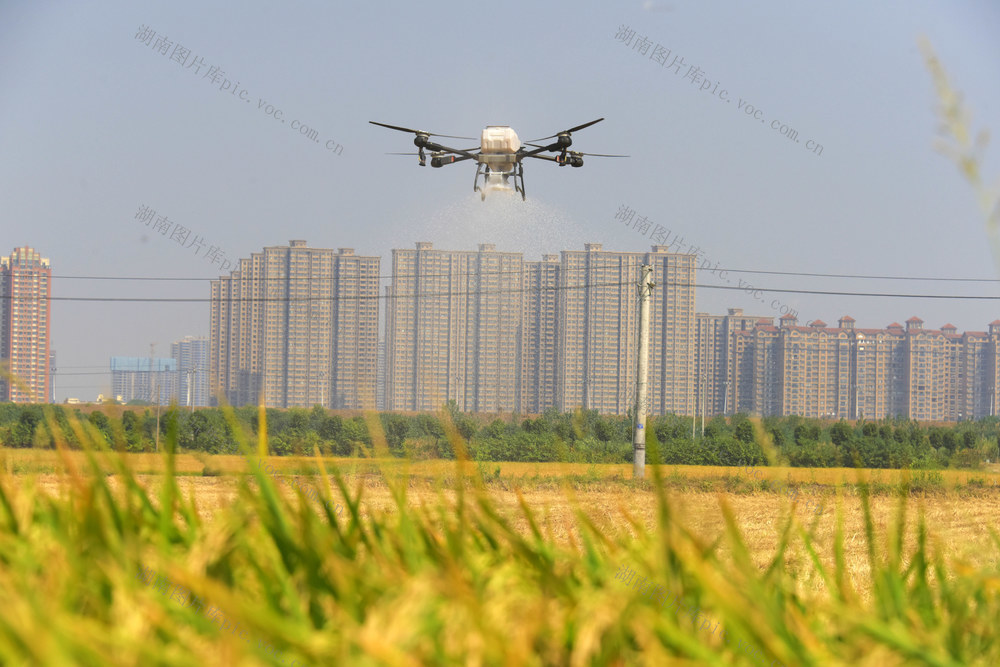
[728,315,1000,421]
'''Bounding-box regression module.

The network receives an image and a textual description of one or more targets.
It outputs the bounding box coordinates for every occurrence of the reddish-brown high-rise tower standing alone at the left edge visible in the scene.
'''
[0,246,52,403]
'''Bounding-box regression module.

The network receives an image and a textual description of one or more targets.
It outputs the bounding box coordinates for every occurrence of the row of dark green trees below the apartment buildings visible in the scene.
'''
[0,403,1000,469]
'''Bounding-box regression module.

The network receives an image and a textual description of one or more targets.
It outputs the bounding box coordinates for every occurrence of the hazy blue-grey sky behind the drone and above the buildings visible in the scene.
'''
[0,0,1000,400]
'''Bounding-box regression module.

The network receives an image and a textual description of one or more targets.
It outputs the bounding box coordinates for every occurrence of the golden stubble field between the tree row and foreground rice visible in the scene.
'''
[2,449,1000,604]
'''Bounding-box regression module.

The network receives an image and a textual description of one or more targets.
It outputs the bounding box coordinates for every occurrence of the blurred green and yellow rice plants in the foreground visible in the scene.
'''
[0,404,1000,665]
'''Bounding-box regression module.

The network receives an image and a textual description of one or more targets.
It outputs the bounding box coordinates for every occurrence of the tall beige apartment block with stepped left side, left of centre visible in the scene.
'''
[209,240,380,409]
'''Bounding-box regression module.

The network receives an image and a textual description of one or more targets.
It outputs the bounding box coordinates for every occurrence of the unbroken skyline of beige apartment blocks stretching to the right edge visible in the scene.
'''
[160,240,1000,421]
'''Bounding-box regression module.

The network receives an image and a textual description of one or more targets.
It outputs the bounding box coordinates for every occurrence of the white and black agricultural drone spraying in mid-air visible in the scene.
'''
[368,118,628,200]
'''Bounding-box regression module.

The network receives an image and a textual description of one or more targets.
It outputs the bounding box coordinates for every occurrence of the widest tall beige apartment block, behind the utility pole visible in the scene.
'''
[386,243,695,413]
